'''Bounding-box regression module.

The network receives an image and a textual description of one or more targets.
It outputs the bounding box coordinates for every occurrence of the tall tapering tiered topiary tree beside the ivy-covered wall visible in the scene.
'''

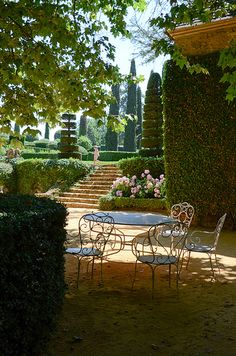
[140,72,163,156]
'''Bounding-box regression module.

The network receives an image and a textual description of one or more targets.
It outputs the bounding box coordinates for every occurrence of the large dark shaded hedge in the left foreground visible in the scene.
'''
[0,195,67,356]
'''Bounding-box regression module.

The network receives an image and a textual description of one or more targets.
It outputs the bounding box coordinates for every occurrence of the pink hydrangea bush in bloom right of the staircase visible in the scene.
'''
[111,169,165,199]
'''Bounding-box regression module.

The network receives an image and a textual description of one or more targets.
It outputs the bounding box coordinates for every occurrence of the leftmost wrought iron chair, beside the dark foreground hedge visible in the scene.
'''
[65,212,124,288]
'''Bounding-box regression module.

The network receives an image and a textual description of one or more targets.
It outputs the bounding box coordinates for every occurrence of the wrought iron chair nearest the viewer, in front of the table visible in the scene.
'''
[132,222,187,297]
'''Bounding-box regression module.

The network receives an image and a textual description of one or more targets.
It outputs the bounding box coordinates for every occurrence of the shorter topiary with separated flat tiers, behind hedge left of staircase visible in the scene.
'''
[59,114,81,158]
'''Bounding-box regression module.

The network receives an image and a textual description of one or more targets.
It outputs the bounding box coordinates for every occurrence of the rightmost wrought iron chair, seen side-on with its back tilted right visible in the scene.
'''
[185,213,227,278]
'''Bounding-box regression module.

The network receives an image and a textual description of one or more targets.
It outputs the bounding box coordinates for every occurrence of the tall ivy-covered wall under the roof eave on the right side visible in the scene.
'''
[163,53,236,228]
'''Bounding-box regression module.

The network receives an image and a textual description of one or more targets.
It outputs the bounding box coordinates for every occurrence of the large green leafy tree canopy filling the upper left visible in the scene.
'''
[0,0,144,133]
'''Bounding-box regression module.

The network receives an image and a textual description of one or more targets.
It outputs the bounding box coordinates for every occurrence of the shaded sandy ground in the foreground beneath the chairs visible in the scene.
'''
[46,211,236,356]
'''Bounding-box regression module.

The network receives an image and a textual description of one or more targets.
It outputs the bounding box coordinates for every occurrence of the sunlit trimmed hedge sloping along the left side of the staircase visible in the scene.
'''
[16,158,92,194]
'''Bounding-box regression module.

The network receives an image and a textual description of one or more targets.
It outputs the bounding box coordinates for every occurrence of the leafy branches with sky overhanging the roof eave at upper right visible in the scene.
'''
[131,0,236,101]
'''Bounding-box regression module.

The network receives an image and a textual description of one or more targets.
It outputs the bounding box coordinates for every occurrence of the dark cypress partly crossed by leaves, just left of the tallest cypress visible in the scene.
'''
[105,84,120,151]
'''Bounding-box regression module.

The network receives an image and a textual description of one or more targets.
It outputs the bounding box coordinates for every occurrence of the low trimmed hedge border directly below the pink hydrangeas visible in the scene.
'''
[99,195,167,213]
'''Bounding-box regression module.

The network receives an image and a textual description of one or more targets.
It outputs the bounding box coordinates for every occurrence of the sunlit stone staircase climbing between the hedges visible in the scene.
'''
[58,165,121,209]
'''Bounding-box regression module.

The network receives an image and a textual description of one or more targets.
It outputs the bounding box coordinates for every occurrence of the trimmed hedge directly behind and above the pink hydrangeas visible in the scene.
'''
[119,157,164,178]
